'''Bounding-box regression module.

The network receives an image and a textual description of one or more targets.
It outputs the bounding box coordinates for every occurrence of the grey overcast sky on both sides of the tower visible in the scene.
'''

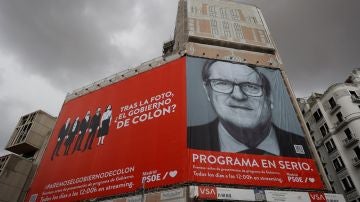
[0,0,360,155]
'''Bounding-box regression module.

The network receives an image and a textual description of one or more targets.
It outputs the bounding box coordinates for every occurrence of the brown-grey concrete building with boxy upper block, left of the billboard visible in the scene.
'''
[0,110,56,202]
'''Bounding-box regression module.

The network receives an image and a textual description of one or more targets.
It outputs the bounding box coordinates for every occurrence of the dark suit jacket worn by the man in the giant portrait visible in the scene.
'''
[187,119,310,158]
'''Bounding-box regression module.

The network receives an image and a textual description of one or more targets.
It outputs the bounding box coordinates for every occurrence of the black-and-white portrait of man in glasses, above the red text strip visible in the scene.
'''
[187,58,310,157]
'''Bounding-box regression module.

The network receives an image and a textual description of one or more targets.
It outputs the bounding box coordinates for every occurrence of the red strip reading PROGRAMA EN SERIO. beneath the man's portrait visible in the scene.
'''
[189,149,323,189]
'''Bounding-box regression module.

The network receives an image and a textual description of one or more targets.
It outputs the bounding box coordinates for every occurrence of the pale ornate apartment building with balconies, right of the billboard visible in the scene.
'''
[298,69,360,202]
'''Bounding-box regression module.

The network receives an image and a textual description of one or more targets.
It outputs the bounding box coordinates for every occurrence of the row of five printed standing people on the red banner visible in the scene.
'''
[51,105,112,160]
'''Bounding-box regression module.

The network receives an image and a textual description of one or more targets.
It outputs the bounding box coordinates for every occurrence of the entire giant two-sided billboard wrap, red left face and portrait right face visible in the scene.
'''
[27,57,323,201]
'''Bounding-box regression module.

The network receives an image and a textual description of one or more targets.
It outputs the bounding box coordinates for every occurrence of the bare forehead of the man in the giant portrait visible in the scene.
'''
[209,61,260,82]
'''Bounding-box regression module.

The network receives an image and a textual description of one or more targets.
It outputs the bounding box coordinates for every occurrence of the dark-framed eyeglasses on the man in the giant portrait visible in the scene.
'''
[206,79,263,97]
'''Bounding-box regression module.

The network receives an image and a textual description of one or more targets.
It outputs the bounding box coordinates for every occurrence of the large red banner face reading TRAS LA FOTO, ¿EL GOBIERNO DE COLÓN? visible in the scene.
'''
[27,58,187,201]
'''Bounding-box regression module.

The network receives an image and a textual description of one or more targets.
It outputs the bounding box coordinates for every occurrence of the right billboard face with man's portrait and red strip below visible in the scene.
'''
[186,57,323,189]
